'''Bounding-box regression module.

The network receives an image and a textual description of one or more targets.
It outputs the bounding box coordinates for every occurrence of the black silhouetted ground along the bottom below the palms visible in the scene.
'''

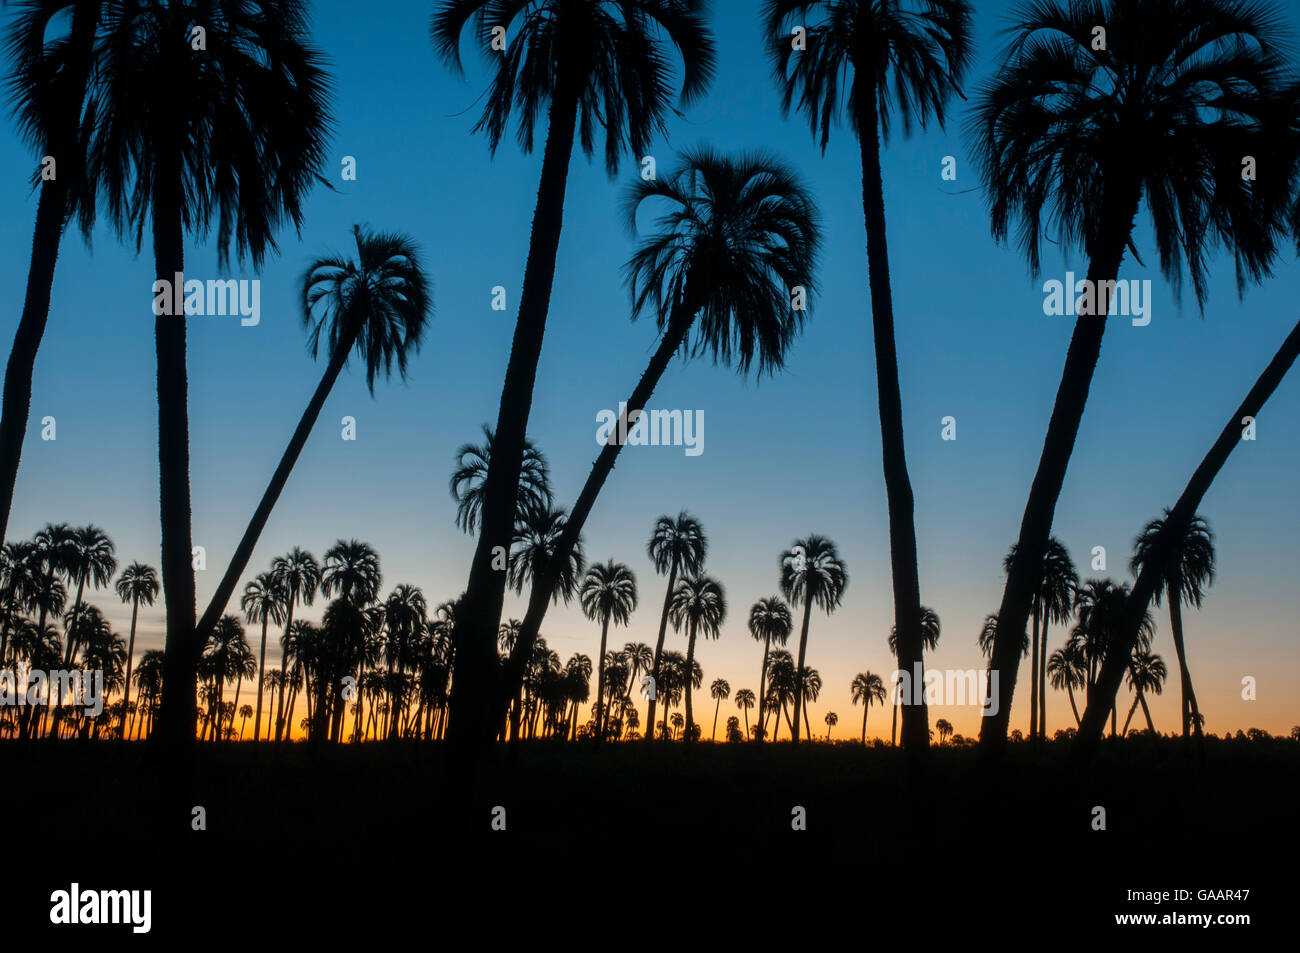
[0,738,1300,949]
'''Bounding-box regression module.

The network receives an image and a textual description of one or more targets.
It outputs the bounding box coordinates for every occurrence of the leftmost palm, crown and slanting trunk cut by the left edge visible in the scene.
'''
[0,0,103,541]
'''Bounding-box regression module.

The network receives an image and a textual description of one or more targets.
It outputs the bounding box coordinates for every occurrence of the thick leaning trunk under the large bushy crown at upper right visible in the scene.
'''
[979,177,1141,757]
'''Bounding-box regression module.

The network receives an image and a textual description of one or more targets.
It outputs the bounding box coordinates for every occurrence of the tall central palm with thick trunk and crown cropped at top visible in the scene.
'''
[430,0,715,742]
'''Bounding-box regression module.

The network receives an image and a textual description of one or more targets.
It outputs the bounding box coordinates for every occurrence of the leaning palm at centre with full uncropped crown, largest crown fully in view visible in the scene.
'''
[493,150,820,738]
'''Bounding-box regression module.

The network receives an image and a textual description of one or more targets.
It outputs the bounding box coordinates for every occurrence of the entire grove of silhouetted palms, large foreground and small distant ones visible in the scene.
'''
[0,0,1300,754]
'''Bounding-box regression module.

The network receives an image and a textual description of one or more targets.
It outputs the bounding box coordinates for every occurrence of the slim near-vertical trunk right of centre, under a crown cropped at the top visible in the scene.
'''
[857,85,930,749]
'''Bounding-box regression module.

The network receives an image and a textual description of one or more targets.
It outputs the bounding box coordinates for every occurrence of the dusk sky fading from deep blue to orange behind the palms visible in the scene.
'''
[0,0,1300,738]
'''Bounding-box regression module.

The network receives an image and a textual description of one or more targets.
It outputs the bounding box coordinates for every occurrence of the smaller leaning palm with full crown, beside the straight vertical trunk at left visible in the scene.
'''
[198,225,433,655]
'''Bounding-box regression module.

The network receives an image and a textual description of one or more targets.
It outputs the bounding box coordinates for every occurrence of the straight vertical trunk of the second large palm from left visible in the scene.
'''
[153,144,200,748]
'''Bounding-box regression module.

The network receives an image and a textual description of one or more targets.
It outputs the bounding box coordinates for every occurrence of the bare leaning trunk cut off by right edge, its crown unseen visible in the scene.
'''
[1075,314,1300,761]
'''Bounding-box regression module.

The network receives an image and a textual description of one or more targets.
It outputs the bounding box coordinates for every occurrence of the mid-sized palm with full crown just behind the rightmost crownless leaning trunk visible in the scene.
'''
[1128,508,1214,738]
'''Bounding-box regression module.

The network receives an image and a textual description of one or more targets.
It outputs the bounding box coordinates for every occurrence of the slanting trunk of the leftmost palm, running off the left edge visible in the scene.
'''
[0,3,100,551]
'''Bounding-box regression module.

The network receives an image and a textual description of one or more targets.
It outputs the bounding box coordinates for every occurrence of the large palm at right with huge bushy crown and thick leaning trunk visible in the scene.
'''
[971,0,1286,751]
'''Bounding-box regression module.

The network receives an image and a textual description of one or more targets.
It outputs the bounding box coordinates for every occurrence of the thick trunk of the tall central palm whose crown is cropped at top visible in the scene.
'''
[449,77,579,745]
